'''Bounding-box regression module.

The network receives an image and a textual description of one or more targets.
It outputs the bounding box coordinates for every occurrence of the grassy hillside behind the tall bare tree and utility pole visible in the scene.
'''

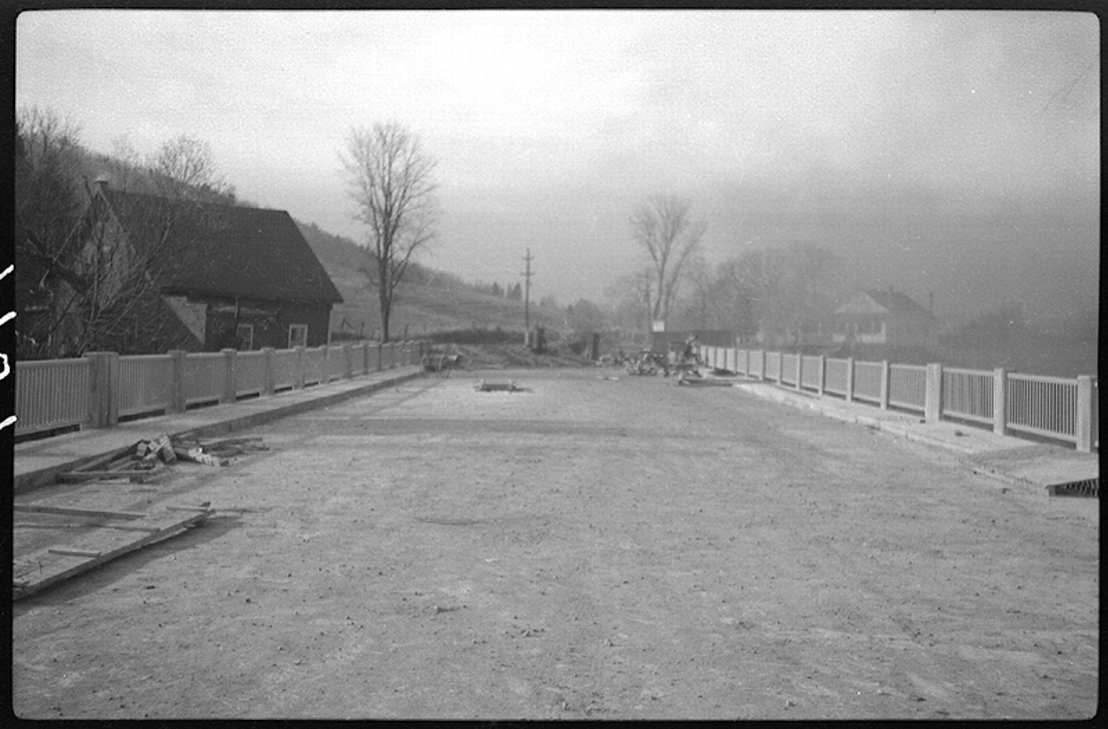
[297,222,564,339]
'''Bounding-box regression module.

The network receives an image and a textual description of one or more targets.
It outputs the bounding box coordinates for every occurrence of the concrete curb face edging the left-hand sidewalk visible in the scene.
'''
[12,370,422,494]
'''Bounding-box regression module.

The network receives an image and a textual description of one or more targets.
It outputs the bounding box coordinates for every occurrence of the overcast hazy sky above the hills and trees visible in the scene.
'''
[16,10,1100,314]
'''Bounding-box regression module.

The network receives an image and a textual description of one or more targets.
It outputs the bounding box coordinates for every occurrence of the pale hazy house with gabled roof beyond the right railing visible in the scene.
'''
[830,287,938,349]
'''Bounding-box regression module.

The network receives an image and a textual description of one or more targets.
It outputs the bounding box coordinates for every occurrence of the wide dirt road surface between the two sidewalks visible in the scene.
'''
[13,370,1099,719]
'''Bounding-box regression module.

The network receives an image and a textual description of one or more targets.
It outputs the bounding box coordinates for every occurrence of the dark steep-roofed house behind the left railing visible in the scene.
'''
[81,184,342,352]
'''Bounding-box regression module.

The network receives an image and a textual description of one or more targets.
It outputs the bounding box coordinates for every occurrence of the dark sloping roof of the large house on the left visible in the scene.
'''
[102,188,342,304]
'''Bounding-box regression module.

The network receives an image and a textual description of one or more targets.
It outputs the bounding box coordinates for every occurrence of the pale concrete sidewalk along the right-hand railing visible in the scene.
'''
[726,378,1100,495]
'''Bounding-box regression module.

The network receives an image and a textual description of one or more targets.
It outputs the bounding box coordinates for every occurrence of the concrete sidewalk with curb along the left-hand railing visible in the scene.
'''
[12,365,421,494]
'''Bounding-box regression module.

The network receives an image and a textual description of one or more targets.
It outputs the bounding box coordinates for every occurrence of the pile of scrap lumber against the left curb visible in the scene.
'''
[58,433,269,483]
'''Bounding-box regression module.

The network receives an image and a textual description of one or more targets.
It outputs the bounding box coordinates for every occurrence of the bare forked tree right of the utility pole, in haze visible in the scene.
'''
[630,195,707,320]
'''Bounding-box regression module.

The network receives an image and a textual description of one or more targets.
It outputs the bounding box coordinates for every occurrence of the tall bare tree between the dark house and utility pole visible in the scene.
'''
[340,122,438,341]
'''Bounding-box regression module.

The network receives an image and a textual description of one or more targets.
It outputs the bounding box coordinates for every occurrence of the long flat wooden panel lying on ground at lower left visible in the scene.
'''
[12,502,214,599]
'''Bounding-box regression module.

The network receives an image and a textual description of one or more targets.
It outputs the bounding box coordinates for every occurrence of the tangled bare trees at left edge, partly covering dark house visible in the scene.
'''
[16,107,222,359]
